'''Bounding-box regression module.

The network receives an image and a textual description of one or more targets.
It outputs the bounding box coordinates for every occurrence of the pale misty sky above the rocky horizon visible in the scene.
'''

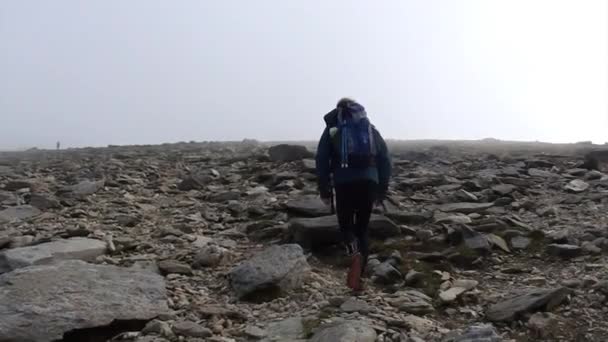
[0,0,608,148]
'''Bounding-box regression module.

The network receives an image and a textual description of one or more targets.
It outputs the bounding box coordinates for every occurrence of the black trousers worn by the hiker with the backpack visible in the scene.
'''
[336,181,378,267]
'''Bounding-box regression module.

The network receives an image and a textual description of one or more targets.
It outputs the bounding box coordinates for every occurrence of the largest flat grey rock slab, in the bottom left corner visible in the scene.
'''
[0,260,168,342]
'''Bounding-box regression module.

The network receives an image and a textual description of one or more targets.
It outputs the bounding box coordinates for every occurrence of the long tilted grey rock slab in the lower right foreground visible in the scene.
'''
[486,287,570,322]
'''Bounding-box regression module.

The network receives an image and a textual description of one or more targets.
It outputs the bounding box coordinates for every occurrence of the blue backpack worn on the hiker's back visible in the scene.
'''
[332,103,377,169]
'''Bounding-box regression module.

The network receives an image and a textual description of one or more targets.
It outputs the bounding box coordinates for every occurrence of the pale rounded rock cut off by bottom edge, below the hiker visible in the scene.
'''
[310,321,377,342]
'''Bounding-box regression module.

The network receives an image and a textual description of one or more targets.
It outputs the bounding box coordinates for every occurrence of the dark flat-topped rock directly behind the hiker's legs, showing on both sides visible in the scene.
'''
[289,215,401,248]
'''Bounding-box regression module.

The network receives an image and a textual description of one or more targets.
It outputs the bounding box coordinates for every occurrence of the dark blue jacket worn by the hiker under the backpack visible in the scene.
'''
[316,109,391,198]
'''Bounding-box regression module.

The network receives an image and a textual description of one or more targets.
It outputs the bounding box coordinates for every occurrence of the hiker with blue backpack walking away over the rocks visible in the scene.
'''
[316,98,391,290]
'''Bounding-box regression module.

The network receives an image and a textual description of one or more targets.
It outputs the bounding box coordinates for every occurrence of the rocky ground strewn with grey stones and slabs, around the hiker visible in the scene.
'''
[0,141,608,342]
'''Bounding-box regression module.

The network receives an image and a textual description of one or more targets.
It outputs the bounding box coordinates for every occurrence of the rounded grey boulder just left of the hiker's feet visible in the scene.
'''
[230,244,310,298]
